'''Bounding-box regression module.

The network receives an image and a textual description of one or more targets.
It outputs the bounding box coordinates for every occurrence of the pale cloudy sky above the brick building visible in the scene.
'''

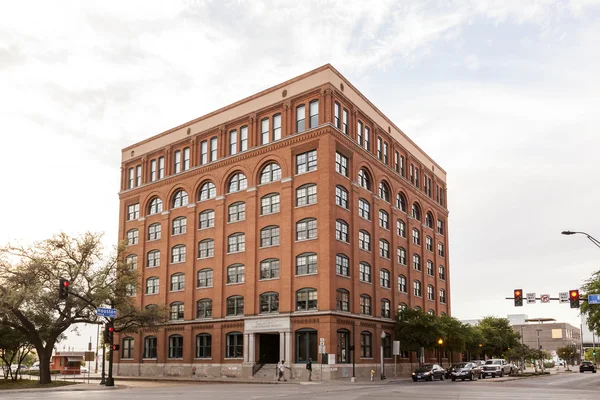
[0,0,600,349]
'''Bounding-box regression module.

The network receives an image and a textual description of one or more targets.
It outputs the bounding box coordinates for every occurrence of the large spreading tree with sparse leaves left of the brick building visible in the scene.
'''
[0,232,166,384]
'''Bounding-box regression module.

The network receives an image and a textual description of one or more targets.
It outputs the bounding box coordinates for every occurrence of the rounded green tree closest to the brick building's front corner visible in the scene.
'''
[396,308,442,362]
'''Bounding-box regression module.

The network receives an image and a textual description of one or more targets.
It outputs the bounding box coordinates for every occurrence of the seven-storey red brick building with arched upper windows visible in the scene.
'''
[116,65,450,379]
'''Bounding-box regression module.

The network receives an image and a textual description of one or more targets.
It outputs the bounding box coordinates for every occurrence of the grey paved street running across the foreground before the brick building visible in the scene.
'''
[0,373,600,400]
